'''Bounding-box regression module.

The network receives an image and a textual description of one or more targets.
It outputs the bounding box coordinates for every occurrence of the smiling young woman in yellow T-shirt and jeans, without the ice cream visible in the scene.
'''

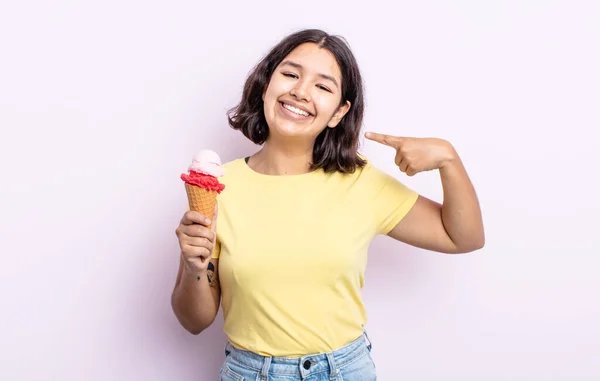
[172,30,484,381]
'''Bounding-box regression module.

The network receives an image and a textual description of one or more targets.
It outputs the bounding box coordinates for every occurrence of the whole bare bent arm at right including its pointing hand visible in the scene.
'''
[366,132,485,253]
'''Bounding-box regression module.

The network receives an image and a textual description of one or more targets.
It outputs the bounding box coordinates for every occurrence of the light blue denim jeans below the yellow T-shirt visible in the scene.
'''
[220,333,377,381]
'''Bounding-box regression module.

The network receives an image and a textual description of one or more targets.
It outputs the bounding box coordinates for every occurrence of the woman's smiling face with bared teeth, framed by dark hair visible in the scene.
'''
[263,43,350,142]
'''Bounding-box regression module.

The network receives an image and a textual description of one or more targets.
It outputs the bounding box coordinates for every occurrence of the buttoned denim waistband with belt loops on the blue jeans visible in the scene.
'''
[225,332,371,379]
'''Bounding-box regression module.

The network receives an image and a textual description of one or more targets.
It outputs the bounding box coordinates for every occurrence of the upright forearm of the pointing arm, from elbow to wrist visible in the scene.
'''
[440,151,485,252]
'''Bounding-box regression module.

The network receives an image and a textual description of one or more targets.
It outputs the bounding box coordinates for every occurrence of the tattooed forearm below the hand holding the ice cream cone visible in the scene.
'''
[171,268,218,334]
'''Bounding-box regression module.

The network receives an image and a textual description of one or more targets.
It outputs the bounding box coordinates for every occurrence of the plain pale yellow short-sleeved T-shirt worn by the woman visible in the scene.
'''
[213,159,418,357]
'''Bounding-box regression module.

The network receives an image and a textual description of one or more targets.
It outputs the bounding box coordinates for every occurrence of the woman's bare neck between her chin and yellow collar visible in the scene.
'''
[248,139,313,176]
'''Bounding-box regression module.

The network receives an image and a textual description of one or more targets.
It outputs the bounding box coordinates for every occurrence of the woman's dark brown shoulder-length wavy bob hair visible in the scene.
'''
[227,29,366,173]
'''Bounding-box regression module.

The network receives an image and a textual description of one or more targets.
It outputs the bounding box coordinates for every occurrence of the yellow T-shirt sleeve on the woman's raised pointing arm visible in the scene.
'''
[365,163,419,234]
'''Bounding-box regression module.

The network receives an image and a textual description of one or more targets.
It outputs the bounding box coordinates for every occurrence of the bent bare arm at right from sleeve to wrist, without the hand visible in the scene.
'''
[388,150,485,254]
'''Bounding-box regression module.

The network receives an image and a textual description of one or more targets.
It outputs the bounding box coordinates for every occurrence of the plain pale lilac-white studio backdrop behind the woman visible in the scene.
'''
[0,0,600,381]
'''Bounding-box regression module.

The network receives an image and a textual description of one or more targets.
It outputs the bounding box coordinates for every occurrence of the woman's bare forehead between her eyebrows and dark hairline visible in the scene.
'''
[282,42,342,82]
